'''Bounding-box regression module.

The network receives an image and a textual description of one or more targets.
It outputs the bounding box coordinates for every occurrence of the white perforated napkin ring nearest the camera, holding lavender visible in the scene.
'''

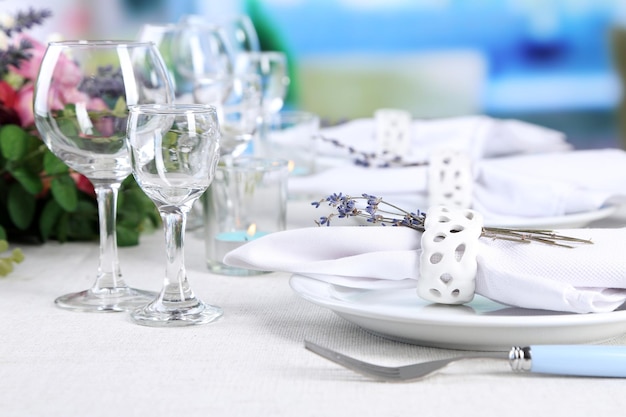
[417,206,483,304]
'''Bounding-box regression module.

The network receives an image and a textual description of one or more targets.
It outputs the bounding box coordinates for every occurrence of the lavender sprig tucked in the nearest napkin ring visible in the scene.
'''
[311,193,593,248]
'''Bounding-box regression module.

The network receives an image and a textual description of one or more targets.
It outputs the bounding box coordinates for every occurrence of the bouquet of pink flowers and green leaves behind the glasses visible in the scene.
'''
[0,9,160,272]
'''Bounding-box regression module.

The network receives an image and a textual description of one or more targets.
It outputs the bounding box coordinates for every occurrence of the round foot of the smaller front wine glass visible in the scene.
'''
[130,300,224,327]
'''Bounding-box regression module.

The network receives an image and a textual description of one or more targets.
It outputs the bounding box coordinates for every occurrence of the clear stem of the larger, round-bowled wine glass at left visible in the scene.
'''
[92,183,126,291]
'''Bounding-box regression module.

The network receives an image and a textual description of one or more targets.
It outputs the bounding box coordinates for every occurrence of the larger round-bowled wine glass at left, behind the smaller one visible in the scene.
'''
[33,41,173,312]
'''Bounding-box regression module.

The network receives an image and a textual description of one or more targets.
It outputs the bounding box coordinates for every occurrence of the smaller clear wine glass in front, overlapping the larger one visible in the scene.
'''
[128,104,222,326]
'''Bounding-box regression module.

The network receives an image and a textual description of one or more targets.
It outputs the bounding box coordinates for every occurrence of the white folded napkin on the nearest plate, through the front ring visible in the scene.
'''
[224,227,626,313]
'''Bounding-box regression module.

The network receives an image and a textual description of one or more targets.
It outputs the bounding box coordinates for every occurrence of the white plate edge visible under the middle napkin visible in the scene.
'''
[485,206,618,229]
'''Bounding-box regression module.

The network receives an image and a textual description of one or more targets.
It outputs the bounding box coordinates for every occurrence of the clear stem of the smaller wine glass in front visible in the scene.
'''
[159,206,196,306]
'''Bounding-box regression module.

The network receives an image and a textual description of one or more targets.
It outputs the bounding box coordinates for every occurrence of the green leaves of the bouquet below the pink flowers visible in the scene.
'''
[0,125,160,247]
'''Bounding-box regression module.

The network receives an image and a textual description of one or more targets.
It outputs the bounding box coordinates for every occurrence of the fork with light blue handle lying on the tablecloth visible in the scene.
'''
[304,340,626,381]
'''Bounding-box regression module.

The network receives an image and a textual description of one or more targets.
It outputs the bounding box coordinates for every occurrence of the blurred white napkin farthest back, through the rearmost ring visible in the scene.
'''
[318,115,572,162]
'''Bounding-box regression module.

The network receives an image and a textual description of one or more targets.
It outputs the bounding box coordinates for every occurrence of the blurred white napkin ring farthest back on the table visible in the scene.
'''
[374,109,412,156]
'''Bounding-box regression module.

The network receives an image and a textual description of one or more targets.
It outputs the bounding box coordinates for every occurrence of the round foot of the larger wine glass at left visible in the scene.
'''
[54,287,158,313]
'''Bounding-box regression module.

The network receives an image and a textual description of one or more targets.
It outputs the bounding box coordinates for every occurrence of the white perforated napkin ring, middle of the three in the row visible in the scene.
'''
[428,149,473,208]
